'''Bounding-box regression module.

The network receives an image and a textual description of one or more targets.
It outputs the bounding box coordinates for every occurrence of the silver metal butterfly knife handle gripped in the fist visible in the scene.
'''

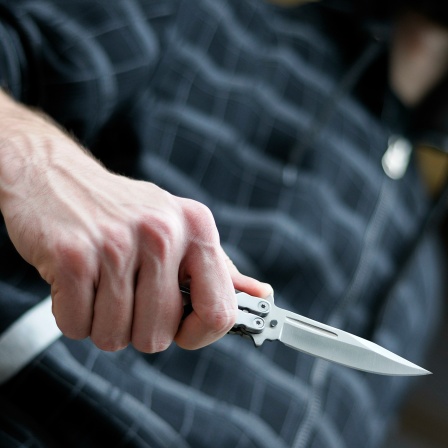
[180,286,272,339]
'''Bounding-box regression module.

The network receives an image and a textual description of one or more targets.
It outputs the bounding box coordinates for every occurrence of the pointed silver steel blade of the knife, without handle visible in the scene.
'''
[253,304,431,375]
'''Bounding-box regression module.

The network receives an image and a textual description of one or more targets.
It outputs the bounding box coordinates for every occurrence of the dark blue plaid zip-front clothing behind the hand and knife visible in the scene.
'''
[0,0,441,448]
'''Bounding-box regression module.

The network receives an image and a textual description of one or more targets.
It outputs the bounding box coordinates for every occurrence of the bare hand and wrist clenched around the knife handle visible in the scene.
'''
[0,91,271,353]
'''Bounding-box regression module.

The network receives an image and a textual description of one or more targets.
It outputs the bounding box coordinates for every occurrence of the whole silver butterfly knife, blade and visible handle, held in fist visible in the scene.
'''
[181,286,431,376]
